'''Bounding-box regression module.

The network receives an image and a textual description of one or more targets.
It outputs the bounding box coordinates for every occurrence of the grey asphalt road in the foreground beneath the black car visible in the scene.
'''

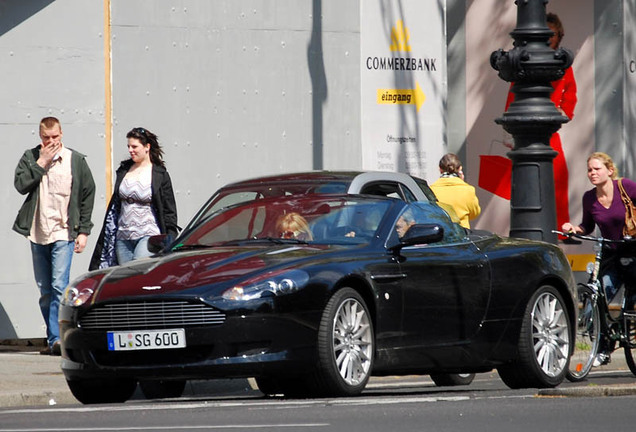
[0,368,636,432]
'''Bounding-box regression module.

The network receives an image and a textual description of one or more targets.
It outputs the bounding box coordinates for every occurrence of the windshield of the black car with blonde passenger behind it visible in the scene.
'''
[173,195,393,249]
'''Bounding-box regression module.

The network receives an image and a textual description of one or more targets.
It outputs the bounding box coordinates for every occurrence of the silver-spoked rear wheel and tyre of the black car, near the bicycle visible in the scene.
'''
[497,285,572,389]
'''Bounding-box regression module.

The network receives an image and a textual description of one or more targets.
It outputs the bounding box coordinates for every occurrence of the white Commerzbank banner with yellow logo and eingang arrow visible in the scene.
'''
[360,0,446,181]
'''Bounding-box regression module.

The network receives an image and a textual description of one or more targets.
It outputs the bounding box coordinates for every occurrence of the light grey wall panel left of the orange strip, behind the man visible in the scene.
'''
[0,0,105,339]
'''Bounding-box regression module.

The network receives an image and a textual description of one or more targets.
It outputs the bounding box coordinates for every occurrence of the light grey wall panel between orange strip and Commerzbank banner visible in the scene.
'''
[112,0,361,224]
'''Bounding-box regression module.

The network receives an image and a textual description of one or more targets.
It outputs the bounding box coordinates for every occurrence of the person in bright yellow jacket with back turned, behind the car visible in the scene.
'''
[431,153,481,228]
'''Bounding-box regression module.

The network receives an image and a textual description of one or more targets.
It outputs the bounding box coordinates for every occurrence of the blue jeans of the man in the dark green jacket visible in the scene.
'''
[31,240,75,346]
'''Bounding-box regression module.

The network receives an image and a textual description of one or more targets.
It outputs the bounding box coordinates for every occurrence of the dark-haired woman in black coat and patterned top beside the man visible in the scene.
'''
[89,127,179,270]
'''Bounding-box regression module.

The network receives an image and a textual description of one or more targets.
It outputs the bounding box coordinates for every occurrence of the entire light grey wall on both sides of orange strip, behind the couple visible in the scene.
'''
[0,0,361,339]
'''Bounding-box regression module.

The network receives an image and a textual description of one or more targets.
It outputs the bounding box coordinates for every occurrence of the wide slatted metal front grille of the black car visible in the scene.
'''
[79,301,225,330]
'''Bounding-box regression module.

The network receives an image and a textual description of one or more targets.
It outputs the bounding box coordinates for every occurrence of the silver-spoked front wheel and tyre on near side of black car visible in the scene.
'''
[313,288,375,396]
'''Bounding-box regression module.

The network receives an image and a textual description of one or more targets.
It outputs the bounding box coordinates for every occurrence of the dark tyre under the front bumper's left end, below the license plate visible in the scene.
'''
[66,379,137,405]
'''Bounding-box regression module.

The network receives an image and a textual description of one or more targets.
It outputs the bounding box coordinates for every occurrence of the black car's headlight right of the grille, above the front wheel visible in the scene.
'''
[223,270,309,301]
